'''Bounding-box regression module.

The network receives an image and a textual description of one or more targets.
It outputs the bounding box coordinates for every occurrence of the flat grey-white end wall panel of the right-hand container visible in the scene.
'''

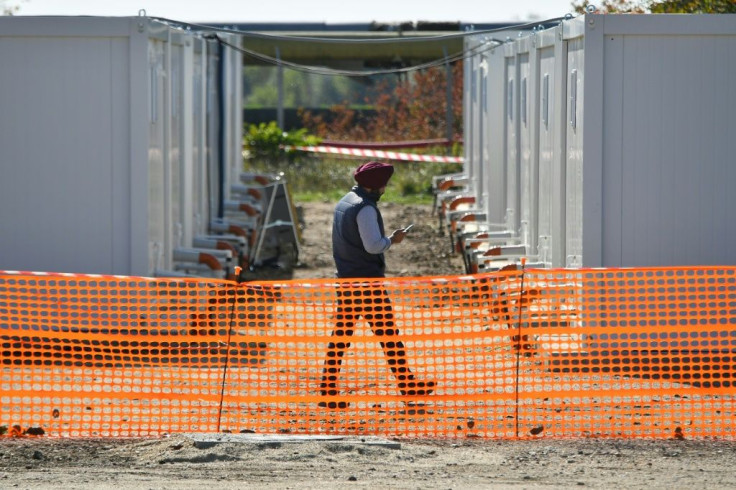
[604,35,736,265]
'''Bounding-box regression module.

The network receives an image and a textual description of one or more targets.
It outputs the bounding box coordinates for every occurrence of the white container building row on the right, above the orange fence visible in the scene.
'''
[465,14,736,267]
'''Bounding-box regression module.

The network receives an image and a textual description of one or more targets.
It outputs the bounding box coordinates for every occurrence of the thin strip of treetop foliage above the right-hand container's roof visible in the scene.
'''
[572,0,736,14]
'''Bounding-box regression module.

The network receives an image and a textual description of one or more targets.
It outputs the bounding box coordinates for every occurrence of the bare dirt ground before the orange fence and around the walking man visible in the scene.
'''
[0,203,736,490]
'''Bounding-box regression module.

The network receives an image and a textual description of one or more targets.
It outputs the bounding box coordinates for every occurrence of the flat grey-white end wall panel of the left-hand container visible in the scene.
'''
[0,34,129,272]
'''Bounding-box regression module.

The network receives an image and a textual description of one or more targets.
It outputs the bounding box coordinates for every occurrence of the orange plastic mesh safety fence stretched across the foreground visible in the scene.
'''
[0,268,736,439]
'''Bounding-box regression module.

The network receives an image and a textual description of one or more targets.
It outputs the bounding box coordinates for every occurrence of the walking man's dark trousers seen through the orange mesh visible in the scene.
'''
[320,288,413,395]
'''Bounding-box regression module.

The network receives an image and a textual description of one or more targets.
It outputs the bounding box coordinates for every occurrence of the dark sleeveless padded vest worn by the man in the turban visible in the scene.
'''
[332,186,386,277]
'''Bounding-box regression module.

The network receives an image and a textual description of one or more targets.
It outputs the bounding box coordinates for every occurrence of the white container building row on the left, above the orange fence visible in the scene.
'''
[0,16,242,275]
